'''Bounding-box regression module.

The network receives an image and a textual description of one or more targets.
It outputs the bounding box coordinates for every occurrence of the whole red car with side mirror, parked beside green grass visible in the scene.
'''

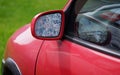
[2,0,120,75]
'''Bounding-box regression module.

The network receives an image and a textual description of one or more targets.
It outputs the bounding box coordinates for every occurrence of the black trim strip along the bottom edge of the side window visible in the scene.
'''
[64,34,120,59]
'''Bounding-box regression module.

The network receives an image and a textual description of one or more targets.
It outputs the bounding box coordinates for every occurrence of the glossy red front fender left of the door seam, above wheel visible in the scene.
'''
[4,25,43,75]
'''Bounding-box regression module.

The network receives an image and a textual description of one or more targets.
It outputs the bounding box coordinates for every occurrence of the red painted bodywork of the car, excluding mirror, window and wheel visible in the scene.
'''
[3,0,120,75]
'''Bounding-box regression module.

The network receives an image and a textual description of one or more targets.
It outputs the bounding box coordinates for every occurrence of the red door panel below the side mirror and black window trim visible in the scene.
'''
[36,40,120,75]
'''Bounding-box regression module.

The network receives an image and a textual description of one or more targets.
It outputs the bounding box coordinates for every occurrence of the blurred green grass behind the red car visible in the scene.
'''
[0,0,67,74]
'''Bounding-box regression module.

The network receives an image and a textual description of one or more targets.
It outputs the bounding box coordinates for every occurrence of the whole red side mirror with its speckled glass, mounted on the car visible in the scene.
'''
[31,10,64,40]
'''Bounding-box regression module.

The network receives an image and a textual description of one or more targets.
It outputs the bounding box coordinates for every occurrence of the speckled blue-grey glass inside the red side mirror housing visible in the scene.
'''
[35,13,61,37]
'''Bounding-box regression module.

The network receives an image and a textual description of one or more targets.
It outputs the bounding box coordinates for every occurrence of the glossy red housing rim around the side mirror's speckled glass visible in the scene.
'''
[31,10,65,40]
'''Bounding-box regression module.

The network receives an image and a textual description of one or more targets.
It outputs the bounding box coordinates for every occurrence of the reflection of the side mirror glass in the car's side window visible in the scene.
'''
[78,16,108,44]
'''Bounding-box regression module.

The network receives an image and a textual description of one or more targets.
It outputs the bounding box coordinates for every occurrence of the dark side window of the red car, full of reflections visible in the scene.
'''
[76,0,120,50]
